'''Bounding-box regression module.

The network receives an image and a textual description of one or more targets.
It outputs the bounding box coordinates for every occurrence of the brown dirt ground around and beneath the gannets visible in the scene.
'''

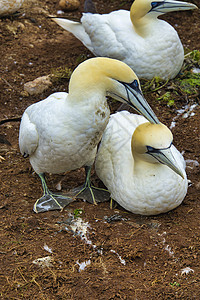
[0,0,200,299]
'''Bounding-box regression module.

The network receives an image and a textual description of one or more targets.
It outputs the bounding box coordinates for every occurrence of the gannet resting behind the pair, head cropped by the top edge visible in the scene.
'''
[53,0,197,79]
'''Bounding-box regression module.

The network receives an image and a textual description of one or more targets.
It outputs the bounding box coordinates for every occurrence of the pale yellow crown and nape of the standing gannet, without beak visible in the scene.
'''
[69,57,139,95]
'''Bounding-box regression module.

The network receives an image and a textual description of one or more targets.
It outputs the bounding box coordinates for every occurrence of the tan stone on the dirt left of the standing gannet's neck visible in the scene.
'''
[24,75,52,95]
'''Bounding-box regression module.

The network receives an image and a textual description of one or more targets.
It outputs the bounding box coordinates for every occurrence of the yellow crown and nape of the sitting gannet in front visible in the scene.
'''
[131,122,173,154]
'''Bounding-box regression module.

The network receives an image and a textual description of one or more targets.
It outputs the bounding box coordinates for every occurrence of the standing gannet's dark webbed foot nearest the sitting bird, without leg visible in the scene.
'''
[71,186,110,204]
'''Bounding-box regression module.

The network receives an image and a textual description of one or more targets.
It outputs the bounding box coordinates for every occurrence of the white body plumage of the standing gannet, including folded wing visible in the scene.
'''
[19,92,106,174]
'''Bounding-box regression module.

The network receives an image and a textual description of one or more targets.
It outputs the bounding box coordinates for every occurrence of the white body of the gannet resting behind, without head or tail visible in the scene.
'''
[80,10,184,79]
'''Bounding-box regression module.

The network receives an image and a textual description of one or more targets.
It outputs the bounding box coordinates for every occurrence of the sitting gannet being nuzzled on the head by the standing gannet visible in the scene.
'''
[95,111,188,215]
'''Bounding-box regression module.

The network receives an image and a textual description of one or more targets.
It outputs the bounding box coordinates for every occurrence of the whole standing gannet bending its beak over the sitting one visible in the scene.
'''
[19,57,159,212]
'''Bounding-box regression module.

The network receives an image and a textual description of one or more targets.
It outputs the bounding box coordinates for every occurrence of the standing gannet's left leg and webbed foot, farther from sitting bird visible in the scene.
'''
[33,173,75,213]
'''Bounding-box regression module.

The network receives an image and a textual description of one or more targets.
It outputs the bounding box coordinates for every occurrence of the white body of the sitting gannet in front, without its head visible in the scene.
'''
[95,111,187,215]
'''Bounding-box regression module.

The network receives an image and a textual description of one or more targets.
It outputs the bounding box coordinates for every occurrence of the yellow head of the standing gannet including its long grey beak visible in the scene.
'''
[69,57,159,123]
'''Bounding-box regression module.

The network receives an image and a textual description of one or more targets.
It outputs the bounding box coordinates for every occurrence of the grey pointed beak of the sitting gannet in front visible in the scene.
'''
[149,148,184,179]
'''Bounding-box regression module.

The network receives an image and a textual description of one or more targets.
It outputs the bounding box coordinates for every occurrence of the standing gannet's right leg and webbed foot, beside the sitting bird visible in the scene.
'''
[70,166,110,204]
